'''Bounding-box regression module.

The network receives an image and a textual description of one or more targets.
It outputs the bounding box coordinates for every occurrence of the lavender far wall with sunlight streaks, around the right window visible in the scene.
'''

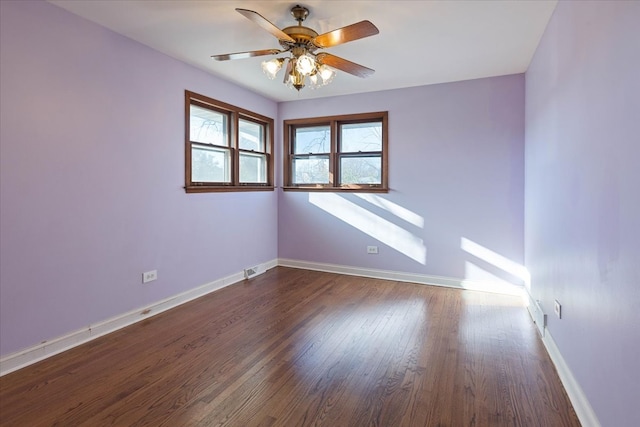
[278,75,524,286]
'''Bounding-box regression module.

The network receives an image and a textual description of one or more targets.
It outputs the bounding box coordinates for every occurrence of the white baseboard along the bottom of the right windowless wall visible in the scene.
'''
[542,330,600,427]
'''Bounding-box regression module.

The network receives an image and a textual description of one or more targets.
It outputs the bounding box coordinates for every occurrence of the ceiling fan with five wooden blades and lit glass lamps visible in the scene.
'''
[212,5,379,90]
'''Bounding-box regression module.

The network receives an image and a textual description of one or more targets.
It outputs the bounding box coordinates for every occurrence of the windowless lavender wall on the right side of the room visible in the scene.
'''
[525,2,640,426]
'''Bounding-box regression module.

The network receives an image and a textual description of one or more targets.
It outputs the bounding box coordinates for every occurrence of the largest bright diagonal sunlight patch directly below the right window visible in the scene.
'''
[309,193,427,265]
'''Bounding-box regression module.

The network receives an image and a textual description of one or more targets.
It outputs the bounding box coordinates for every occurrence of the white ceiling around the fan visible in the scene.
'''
[49,0,557,101]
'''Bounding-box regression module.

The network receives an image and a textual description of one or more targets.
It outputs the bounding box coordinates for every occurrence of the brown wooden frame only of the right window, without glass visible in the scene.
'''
[283,111,389,193]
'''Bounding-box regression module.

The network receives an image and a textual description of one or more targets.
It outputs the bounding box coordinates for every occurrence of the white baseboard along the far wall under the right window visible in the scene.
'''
[278,258,524,297]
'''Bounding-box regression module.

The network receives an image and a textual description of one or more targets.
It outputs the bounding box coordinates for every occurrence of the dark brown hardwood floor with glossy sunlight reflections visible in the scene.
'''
[0,267,580,427]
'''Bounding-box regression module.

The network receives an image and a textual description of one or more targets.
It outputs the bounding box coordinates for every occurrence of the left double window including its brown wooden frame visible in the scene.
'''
[185,91,273,193]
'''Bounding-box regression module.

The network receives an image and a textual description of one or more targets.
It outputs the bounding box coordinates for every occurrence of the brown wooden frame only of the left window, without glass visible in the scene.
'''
[184,90,274,193]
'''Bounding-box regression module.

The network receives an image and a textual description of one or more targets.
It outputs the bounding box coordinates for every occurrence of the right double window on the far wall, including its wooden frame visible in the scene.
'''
[284,111,388,192]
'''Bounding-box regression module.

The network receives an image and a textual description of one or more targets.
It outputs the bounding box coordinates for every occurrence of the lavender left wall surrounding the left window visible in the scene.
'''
[0,1,277,355]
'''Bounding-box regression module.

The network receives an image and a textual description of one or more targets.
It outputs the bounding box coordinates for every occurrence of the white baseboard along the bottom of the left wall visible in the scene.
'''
[0,260,277,376]
